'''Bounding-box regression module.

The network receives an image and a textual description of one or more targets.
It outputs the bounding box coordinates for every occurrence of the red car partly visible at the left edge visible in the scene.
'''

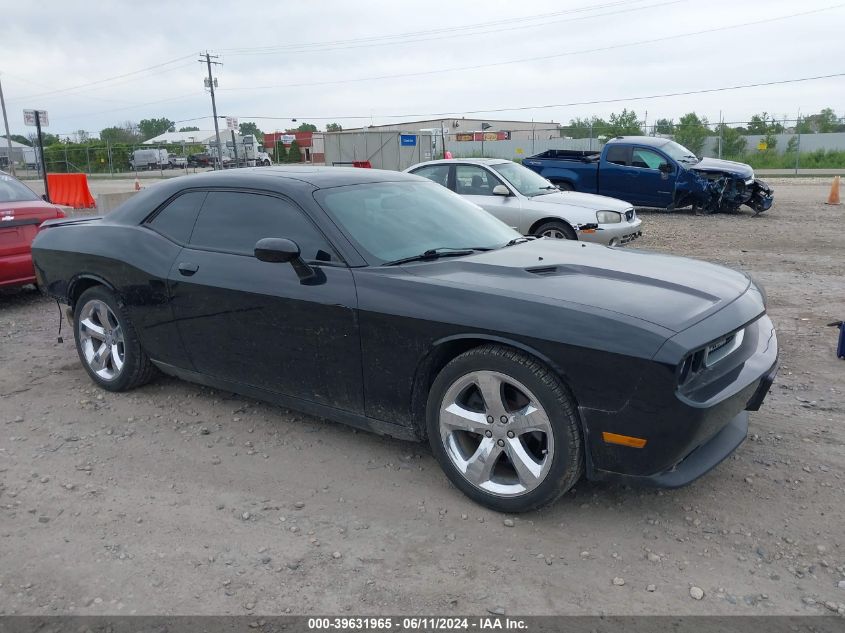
[0,171,65,288]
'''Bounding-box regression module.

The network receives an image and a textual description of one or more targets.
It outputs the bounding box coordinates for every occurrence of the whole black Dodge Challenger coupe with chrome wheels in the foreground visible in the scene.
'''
[33,167,778,512]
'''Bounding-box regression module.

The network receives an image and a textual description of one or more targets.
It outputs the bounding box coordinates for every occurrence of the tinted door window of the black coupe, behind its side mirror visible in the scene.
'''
[191,191,339,262]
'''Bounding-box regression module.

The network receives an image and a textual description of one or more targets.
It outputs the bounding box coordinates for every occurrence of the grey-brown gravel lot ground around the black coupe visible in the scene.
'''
[0,179,845,615]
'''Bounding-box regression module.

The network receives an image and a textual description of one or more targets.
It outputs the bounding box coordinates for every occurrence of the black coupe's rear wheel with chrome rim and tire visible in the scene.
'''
[73,286,153,391]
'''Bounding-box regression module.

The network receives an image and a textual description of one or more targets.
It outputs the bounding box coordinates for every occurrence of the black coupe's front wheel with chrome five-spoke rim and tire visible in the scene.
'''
[426,345,584,512]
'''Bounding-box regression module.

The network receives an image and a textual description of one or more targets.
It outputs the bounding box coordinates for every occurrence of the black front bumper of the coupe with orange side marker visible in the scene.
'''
[581,315,778,487]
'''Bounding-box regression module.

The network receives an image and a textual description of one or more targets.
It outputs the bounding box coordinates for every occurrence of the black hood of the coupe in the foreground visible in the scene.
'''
[405,239,752,332]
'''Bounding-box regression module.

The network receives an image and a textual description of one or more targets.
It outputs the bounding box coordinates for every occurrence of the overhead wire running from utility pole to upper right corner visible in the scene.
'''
[216,3,845,91]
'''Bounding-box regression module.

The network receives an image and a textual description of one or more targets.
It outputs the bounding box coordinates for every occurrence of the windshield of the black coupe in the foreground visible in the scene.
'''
[314,182,520,264]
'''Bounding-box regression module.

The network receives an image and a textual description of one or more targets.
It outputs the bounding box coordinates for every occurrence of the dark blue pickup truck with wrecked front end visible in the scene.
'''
[522,136,774,213]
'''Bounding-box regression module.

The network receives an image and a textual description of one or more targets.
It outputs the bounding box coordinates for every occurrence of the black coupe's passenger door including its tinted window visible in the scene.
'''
[169,190,363,413]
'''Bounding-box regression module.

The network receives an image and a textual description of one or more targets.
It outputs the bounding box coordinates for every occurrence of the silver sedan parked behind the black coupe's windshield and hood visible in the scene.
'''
[405,158,642,246]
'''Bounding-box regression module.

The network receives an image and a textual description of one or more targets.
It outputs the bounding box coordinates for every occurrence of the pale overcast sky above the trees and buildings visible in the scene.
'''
[0,0,845,134]
